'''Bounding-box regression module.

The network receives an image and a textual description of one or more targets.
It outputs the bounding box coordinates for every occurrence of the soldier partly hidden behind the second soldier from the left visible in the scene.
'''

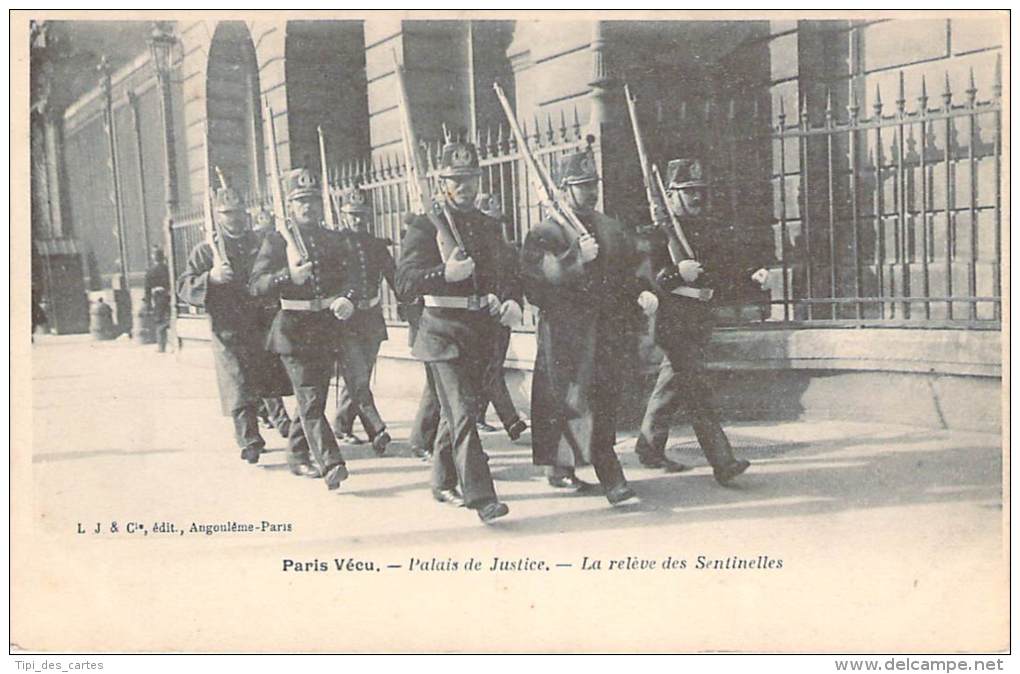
[334,188,397,456]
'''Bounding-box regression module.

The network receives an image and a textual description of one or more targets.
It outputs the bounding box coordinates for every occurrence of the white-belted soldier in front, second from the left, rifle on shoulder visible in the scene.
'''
[249,168,360,489]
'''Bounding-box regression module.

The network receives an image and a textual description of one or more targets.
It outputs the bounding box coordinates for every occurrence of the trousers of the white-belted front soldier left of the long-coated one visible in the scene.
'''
[428,356,496,508]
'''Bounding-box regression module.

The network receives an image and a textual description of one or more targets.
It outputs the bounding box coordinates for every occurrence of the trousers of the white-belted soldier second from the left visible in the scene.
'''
[279,351,344,474]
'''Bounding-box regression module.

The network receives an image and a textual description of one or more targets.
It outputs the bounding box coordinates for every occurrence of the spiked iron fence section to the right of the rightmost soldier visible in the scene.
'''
[701,61,1002,329]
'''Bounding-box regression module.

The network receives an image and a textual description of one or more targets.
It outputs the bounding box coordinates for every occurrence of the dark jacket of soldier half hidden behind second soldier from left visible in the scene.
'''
[341,229,397,342]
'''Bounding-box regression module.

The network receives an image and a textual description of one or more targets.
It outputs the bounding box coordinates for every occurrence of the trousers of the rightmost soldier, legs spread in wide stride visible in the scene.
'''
[634,338,732,466]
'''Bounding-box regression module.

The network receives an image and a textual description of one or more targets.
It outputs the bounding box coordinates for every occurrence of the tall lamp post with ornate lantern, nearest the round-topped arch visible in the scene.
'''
[149,21,180,350]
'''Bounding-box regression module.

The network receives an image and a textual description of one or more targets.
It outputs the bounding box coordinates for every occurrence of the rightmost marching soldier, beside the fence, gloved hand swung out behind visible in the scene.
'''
[635,159,768,484]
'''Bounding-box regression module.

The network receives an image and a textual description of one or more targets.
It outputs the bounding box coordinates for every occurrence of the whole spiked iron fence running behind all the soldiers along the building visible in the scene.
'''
[173,65,1002,329]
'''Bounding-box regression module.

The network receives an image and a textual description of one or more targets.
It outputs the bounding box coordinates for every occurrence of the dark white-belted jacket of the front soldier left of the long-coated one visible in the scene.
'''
[397,209,521,362]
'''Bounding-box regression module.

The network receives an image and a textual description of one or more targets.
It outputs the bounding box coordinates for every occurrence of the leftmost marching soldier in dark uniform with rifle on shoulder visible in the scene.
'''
[177,188,291,463]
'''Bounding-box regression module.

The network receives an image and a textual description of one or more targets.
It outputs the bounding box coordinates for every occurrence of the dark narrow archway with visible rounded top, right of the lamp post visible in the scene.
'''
[206,21,265,198]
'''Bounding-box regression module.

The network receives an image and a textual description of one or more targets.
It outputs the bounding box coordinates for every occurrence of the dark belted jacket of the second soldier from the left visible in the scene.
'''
[248,226,361,354]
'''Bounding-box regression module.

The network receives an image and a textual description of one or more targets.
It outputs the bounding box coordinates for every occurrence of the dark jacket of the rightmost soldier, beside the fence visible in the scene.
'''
[646,217,770,346]
